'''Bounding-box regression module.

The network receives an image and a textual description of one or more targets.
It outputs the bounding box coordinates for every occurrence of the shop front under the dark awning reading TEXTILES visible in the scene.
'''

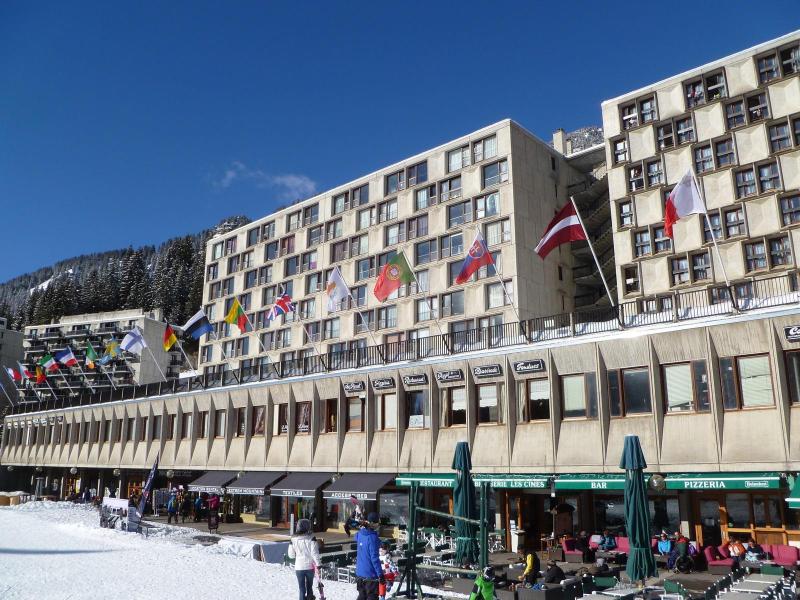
[270,473,335,531]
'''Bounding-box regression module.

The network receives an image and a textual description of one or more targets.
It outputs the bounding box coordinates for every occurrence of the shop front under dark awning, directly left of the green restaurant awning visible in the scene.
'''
[322,473,394,529]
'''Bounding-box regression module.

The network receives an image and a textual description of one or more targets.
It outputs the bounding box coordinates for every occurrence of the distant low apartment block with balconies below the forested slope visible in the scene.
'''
[20,309,183,402]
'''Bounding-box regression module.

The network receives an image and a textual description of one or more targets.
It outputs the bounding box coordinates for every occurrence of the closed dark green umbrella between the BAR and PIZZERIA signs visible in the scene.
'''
[619,435,658,582]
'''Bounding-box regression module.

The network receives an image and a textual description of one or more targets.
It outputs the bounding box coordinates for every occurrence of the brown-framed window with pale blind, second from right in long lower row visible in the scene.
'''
[719,354,774,410]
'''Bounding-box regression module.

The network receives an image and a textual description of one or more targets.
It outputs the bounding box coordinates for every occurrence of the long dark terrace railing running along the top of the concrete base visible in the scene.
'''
[13,273,800,413]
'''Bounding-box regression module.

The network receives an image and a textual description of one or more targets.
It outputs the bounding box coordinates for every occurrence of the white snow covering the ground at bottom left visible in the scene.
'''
[0,502,356,600]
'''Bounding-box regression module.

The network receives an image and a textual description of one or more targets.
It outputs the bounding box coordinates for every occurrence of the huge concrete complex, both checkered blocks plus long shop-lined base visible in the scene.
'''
[0,34,800,548]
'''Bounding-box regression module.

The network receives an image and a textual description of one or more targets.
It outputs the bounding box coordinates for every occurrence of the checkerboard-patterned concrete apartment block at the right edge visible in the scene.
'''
[602,31,800,310]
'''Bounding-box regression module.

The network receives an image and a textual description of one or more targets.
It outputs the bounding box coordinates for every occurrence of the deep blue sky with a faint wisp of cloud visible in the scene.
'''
[0,0,800,281]
